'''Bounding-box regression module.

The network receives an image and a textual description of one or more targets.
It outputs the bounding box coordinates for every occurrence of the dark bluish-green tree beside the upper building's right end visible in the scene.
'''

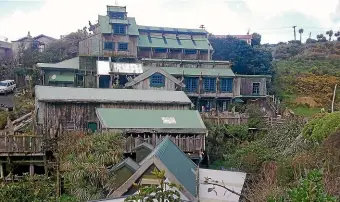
[209,37,272,74]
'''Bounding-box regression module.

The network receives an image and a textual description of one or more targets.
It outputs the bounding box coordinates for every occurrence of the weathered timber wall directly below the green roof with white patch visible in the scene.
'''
[125,133,205,153]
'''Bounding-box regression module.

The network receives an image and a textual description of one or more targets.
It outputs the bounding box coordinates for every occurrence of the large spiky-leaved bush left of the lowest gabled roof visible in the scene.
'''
[56,133,124,201]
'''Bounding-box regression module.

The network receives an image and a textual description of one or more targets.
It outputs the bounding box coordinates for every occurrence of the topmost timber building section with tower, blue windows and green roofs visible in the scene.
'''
[79,6,213,61]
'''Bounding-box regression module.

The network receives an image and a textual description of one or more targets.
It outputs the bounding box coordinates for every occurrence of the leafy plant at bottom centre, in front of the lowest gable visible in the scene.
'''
[125,168,182,202]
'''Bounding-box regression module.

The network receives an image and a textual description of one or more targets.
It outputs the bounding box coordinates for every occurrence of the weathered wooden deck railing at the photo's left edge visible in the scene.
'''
[0,135,43,154]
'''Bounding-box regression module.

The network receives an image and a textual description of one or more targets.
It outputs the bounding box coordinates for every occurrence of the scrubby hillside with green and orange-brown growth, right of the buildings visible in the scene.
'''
[270,42,340,116]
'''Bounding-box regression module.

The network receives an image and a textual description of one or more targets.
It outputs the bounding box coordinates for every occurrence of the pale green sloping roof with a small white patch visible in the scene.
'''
[97,108,206,133]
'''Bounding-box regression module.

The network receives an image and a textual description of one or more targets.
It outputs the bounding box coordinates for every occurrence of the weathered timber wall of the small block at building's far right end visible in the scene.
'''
[239,77,267,95]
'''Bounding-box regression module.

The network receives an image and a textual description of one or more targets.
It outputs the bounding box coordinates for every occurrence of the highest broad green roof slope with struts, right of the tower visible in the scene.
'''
[138,35,213,50]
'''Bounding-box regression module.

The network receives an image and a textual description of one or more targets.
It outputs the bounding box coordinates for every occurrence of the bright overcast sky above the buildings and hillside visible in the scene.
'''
[0,0,340,43]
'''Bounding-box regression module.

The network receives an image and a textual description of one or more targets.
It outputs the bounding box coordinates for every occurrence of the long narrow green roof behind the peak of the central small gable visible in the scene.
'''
[143,66,235,77]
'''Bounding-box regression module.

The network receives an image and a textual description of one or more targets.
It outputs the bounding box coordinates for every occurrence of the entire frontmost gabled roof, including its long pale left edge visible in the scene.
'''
[111,137,197,200]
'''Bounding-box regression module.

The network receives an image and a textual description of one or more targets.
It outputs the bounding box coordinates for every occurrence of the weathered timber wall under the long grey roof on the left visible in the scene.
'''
[37,102,190,135]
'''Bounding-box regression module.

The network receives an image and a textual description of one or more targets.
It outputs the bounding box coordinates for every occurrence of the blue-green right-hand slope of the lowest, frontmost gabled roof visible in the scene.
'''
[140,137,197,196]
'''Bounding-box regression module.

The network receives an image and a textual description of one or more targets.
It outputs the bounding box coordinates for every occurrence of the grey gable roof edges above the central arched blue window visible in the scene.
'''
[125,67,185,88]
